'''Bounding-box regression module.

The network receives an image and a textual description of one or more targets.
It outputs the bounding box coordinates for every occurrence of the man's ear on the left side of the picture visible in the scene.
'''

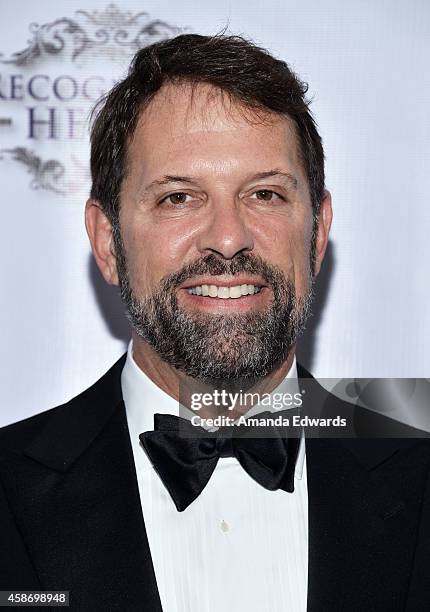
[85,198,118,285]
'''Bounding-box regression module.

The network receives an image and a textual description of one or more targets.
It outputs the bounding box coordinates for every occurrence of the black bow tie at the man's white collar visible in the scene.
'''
[139,412,300,512]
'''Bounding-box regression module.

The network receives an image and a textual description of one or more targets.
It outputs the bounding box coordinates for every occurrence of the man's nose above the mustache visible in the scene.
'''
[197,202,254,259]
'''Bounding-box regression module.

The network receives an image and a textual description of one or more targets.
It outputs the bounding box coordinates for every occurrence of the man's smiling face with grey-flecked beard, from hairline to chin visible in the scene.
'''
[91,85,332,381]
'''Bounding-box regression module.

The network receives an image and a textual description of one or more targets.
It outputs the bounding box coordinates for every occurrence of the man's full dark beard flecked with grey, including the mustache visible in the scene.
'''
[114,231,314,386]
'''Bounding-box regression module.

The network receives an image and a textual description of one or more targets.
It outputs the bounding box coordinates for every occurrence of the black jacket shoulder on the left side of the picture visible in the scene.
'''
[0,354,126,450]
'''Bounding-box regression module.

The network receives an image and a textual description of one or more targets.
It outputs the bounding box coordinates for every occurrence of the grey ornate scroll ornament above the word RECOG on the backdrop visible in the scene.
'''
[0,4,180,66]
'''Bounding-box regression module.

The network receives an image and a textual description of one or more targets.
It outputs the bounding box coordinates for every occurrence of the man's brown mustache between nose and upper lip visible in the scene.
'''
[160,253,285,290]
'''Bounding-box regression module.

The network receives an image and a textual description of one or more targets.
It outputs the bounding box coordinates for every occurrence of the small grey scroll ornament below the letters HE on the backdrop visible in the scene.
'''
[0,147,65,194]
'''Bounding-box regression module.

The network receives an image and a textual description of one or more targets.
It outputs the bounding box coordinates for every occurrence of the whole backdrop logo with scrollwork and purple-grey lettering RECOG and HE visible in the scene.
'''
[0,4,182,195]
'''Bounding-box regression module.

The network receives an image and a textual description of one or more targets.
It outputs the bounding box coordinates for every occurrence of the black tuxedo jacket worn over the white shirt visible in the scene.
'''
[0,356,430,612]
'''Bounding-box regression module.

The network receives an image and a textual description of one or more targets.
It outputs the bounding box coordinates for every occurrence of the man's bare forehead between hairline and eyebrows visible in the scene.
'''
[127,83,304,185]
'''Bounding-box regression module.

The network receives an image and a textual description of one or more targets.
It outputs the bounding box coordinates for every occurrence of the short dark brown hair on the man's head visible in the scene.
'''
[91,34,324,229]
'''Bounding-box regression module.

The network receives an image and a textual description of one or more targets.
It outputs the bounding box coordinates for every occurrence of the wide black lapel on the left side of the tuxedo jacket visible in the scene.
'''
[2,361,161,612]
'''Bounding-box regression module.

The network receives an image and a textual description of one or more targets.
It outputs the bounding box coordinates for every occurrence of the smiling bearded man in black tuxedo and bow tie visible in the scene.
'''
[0,35,430,612]
